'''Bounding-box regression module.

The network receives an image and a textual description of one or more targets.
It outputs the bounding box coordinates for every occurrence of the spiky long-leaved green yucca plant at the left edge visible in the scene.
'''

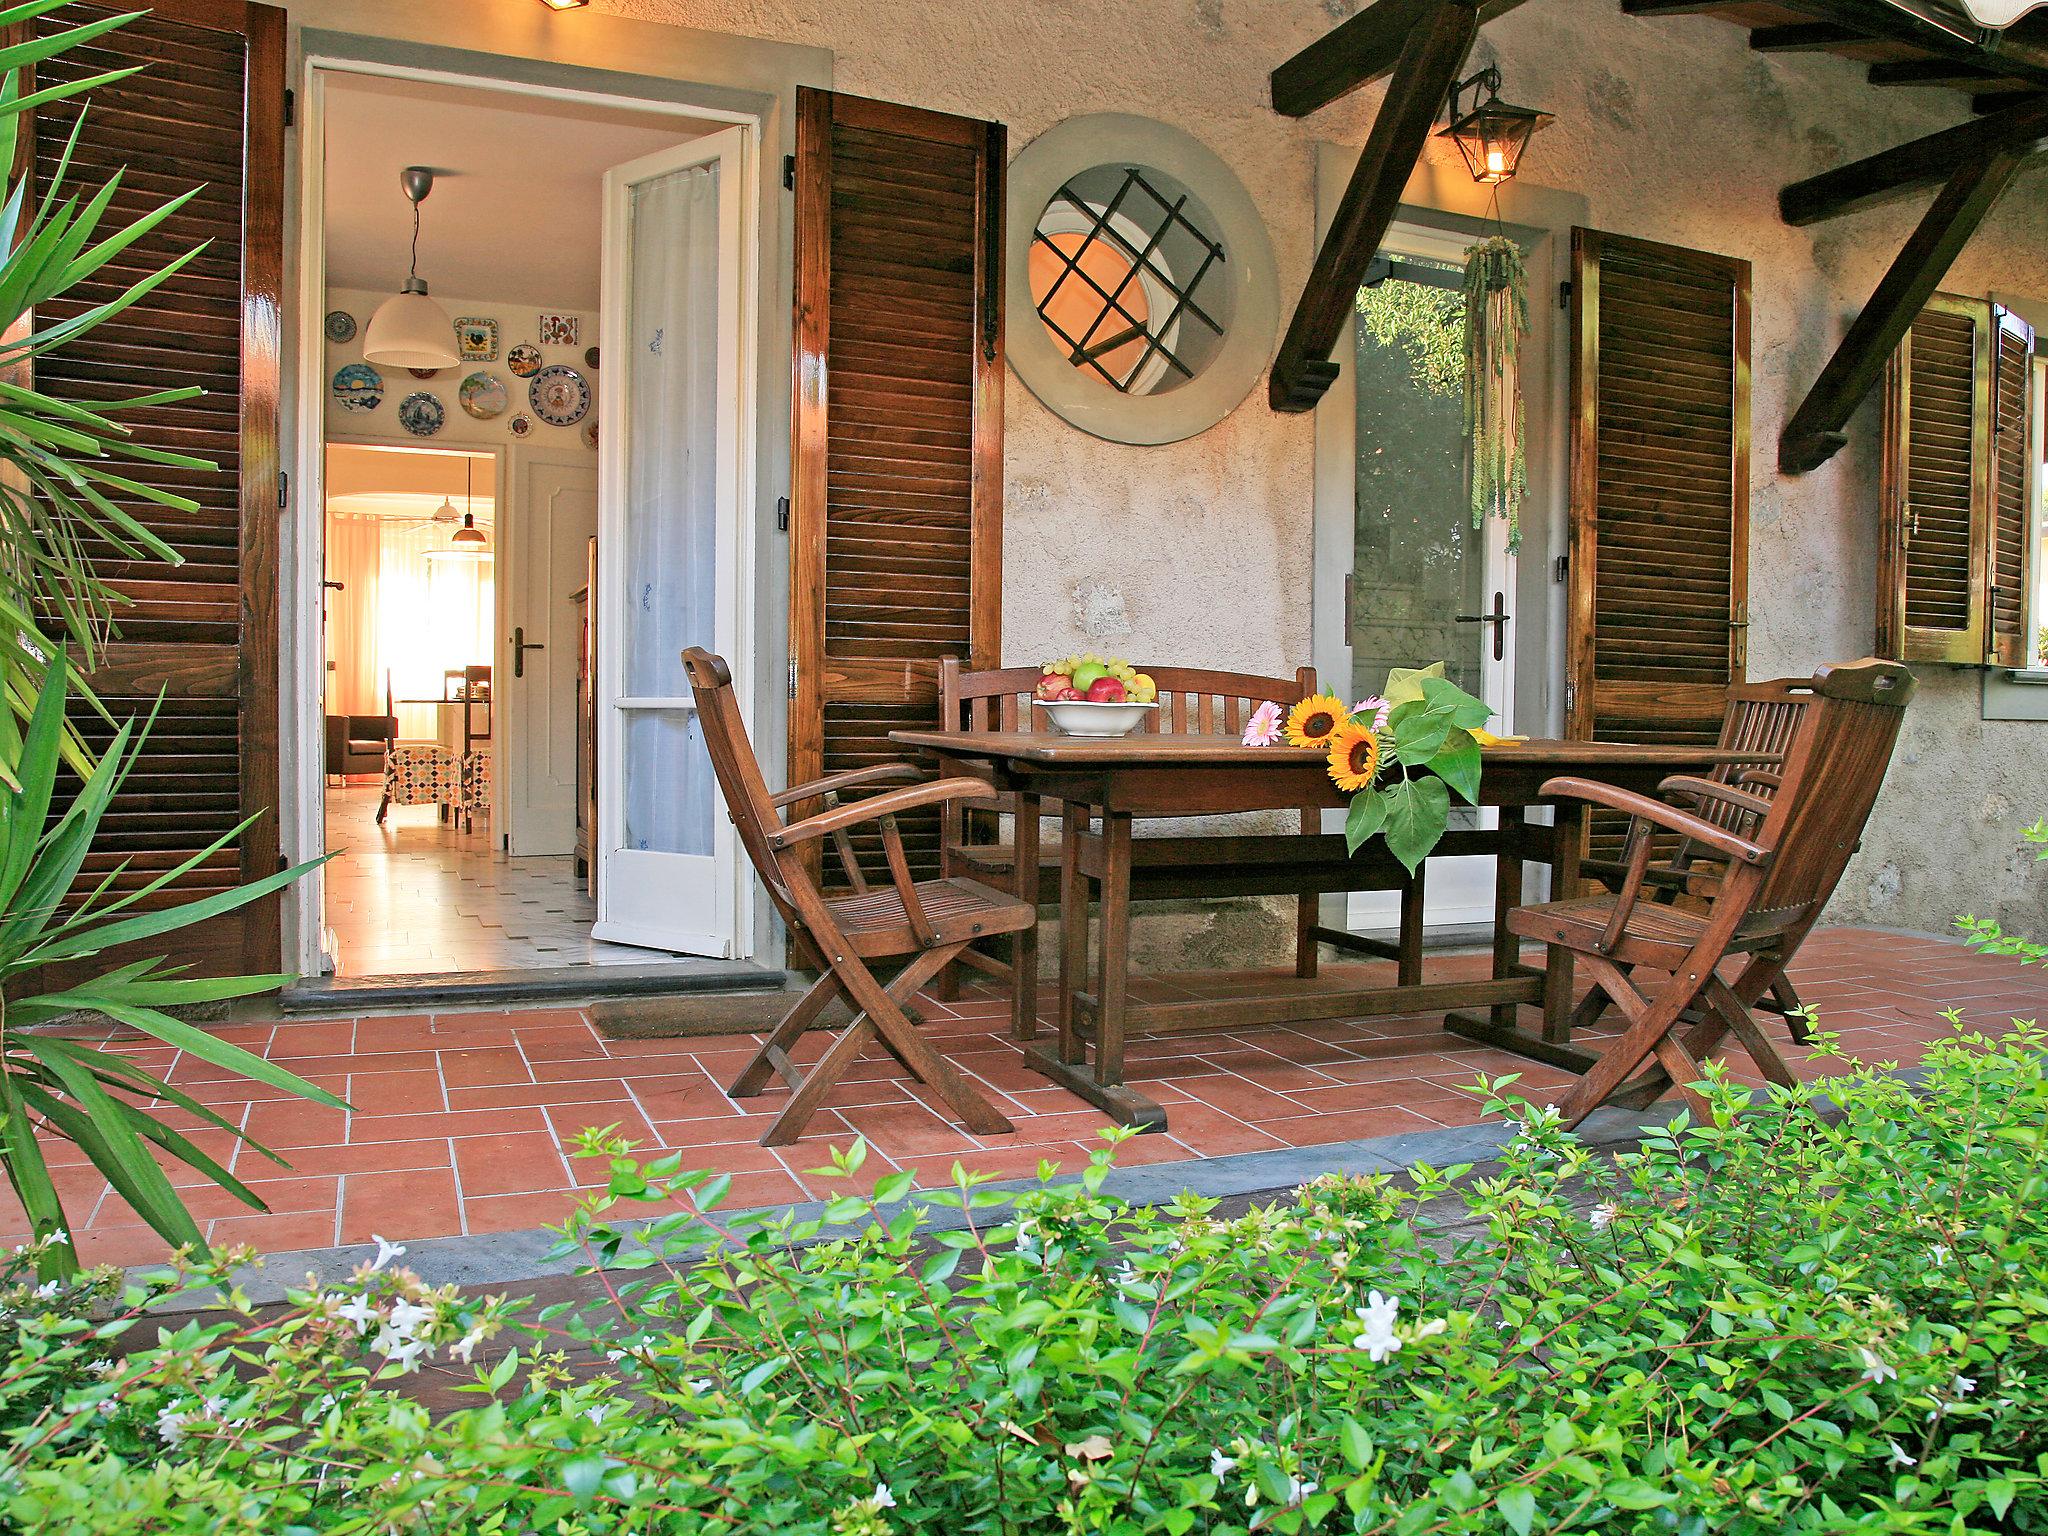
[0,0,340,1274]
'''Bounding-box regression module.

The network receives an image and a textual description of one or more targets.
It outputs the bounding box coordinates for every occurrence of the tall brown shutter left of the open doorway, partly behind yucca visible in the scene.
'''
[33,0,285,973]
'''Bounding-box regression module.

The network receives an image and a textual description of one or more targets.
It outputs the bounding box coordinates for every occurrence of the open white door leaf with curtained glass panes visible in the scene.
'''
[594,127,750,956]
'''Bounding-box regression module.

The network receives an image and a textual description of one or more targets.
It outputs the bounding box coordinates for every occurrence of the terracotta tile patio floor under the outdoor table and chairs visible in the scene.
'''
[19,930,2048,1264]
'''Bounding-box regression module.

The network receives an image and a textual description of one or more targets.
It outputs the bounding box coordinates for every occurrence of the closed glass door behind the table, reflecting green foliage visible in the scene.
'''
[1319,225,1542,930]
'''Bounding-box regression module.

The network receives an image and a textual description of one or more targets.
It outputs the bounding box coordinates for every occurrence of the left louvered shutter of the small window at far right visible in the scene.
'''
[1878,293,1995,662]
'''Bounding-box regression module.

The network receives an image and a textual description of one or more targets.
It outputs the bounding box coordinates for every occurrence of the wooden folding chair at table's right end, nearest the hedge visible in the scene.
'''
[1507,659,1913,1124]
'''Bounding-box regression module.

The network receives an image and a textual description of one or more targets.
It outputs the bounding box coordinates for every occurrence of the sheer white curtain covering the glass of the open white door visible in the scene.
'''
[608,164,719,854]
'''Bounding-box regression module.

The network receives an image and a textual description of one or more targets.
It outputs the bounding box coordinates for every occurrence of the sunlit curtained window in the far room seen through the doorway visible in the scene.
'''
[328,514,496,739]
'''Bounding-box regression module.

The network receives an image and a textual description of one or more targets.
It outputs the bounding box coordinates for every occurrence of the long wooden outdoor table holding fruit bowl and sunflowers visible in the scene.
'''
[889,731,1761,1130]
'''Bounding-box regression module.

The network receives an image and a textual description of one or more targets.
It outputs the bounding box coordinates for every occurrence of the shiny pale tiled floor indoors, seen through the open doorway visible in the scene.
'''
[326,780,670,977]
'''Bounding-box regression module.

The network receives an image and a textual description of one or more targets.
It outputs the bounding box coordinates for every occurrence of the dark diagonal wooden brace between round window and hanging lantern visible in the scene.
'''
[1266,0,1479,412]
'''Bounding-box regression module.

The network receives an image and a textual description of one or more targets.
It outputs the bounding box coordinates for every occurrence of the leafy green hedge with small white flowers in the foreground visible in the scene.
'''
[0,1026,2048,1536]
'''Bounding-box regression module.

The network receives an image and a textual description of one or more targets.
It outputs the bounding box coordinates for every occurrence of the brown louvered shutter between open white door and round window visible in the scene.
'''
[788,90,1006,884]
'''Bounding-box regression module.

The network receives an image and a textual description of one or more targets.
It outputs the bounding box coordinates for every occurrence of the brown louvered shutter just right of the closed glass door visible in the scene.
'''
[1565,229,1749,852]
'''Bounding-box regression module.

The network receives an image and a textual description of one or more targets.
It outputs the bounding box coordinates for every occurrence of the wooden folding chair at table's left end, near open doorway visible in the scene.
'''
[682,645,1036,1147]
